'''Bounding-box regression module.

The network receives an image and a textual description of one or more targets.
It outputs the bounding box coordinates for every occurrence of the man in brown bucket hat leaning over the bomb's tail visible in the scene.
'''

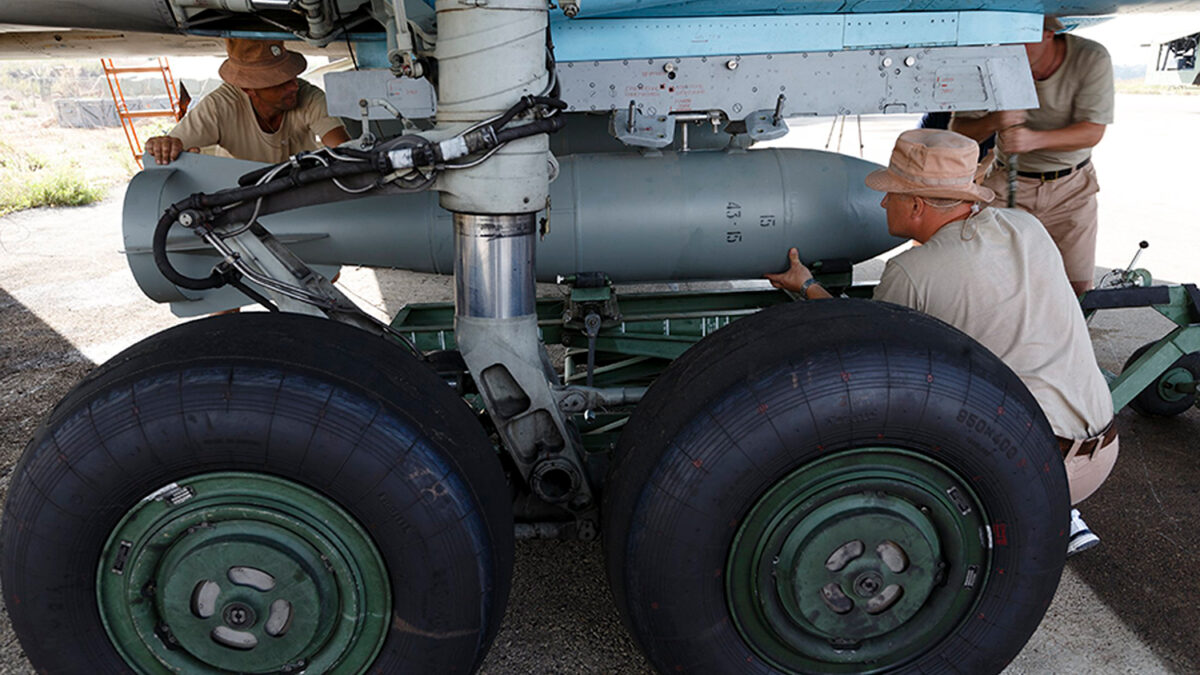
[145,38,349,165]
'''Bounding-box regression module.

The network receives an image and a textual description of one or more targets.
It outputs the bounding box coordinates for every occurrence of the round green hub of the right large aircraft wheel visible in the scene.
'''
[725,448,989,673]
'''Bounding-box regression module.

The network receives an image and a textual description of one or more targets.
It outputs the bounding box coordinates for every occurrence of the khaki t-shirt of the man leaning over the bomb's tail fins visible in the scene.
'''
[168,79,342,163]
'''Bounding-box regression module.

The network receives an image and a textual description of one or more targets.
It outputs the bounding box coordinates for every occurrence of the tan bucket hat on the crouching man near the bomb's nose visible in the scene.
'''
[866,129,996,202]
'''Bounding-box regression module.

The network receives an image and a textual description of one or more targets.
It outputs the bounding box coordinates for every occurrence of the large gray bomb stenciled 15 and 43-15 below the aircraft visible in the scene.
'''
[124,148,902,315]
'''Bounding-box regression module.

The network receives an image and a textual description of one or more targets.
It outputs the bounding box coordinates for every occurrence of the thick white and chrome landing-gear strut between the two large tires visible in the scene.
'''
[436,0,595,513]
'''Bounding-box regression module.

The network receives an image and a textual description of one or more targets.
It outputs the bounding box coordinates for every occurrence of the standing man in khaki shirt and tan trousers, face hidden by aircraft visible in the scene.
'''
[950,17,1114,294]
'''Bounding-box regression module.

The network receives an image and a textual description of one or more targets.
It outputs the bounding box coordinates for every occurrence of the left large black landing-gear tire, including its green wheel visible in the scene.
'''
[0,313,514,675]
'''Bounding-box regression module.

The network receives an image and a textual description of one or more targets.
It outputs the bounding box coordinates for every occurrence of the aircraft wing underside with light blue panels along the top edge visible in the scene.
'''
[0,0,1200,61]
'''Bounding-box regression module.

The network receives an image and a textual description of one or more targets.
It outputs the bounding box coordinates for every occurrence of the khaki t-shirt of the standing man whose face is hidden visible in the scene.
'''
[954,34,1114,172]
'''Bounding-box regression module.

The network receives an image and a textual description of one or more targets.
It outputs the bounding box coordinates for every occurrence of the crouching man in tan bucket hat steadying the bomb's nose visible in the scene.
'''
[767,129,1117,554]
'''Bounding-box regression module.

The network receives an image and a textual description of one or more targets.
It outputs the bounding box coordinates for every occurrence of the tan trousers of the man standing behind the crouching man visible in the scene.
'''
[983,160,1100,282]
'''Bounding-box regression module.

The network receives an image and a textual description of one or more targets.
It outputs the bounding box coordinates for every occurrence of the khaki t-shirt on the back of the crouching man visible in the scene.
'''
[875,208,1112,438]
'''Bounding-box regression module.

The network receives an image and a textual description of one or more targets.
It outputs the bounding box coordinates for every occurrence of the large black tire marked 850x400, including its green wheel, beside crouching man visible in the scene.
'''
[602,300,1069,674]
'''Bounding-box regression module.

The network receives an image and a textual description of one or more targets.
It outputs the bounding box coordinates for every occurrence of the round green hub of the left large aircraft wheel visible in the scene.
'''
[96,473,391,674]
